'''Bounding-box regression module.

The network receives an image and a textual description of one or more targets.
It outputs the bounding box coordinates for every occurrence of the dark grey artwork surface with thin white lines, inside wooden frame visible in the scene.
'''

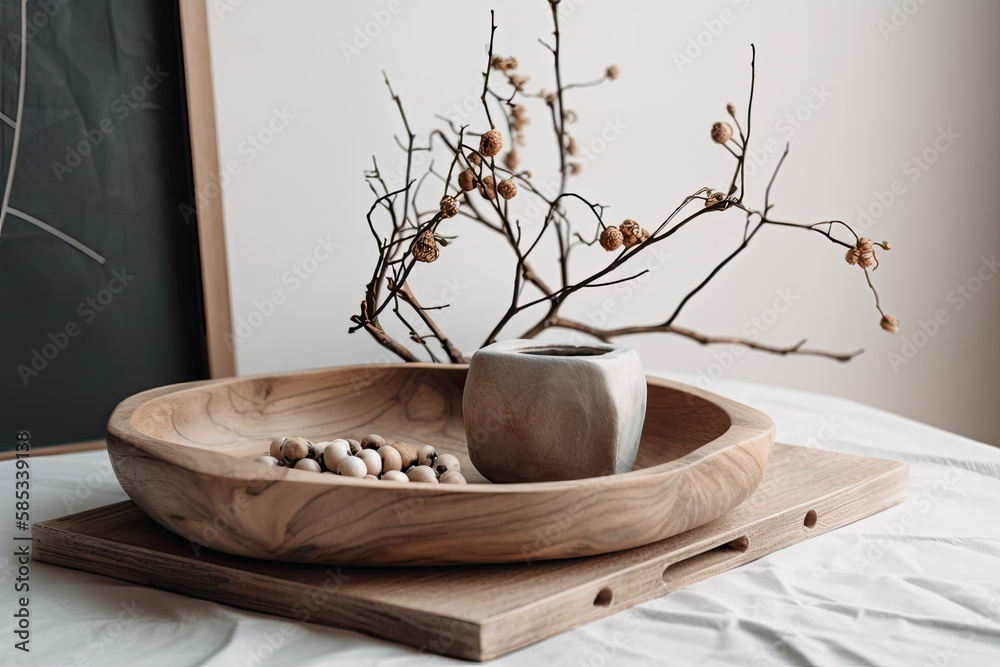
[0,0,208,451]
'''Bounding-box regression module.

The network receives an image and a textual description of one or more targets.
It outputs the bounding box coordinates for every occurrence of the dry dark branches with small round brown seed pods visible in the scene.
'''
[349,3,898,363]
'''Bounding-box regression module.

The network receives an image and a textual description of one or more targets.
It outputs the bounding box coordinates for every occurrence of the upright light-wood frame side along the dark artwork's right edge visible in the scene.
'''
[180,0,236,378]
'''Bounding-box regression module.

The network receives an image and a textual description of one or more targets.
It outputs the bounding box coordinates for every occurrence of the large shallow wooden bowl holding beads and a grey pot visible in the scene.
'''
[108,364,774,565]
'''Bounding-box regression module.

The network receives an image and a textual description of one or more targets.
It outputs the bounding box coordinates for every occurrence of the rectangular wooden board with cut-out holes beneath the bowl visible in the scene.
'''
[33,445,909,660]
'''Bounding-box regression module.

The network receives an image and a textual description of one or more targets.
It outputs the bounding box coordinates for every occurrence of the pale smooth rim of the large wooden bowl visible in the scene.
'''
[107,362,775,495]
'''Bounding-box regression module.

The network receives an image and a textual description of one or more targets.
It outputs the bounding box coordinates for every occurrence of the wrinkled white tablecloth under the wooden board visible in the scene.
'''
[0,376,1000,667]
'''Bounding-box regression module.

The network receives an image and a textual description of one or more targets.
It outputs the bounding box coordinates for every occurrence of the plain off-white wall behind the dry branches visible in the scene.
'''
[200,0,1000,444]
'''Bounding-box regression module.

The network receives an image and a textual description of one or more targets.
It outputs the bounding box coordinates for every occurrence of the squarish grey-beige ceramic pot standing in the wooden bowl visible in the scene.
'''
[462,340,646,482]
